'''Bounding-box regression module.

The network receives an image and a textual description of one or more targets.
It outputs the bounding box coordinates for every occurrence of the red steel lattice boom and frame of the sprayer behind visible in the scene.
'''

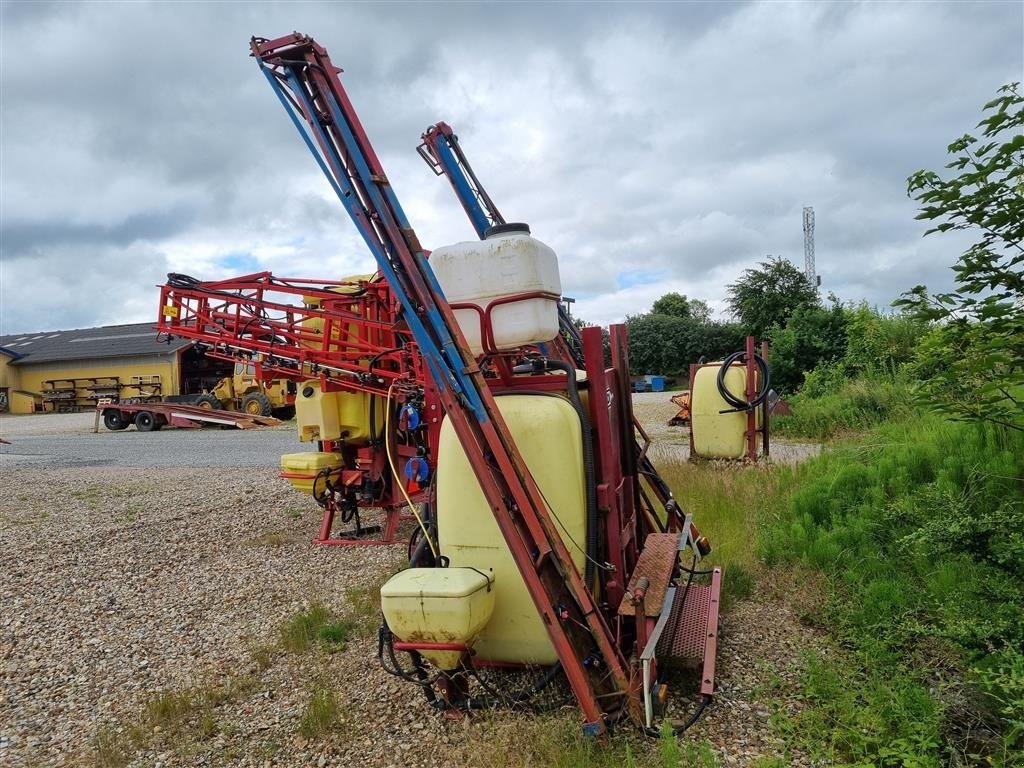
[157,272,440,546]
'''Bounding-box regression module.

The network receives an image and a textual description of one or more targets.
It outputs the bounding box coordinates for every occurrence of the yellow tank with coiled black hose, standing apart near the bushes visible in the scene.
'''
[690,364,746,459]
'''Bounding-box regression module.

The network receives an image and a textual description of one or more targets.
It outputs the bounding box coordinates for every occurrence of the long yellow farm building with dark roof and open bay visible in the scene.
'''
[0,323,231,414]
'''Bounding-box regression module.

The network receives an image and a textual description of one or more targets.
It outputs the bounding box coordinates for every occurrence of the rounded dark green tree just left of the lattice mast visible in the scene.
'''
[728,256,818,338]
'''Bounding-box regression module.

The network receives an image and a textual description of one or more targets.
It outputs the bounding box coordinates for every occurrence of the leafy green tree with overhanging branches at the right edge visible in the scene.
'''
[895,83,1024,430]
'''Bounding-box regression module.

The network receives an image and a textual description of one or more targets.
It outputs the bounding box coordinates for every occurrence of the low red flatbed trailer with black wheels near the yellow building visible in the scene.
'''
[92,401,281,432]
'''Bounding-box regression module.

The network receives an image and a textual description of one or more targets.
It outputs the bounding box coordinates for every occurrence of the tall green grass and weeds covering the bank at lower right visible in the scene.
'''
[657,379,1024,768]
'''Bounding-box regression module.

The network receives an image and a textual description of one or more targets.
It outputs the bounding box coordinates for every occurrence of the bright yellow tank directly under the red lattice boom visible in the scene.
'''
[295,380,384,445]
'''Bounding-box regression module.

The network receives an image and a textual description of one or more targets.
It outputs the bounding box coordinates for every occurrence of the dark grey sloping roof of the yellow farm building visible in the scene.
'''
[0,323,191,366]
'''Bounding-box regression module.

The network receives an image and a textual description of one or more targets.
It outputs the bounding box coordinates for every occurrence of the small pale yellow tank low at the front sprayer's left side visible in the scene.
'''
[381,567,496,670]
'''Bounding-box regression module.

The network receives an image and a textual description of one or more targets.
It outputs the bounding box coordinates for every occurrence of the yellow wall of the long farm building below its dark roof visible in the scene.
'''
[11,354,178,413]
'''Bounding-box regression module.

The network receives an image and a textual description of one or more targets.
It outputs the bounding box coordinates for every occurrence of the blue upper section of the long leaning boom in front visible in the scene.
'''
[258,61,488,423]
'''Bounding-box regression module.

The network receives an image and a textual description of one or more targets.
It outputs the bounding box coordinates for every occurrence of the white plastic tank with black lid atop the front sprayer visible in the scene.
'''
[430,224,562,355]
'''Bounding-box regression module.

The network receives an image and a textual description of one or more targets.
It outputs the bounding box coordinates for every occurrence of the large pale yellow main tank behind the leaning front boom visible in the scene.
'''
[436,394,587,665]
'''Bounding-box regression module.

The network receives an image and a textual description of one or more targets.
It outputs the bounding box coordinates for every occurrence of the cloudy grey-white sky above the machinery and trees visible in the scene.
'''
[0,0,1024,334]
